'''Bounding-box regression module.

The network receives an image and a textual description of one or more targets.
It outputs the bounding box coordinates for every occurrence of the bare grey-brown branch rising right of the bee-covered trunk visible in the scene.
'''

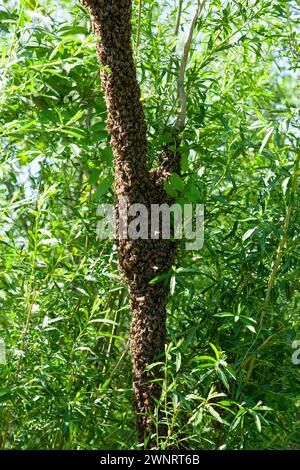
[175,0,206,132]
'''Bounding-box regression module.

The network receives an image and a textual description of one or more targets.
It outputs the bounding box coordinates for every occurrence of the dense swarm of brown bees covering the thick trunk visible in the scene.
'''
[82,0,180,440]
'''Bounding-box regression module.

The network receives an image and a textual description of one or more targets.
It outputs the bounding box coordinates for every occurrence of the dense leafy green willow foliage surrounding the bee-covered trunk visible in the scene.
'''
[0,0,300,449]
